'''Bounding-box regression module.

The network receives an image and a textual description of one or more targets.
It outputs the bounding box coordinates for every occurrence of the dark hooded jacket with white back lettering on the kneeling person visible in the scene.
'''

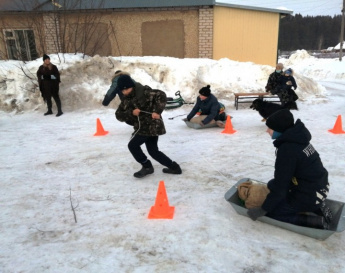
[262,119,329,212]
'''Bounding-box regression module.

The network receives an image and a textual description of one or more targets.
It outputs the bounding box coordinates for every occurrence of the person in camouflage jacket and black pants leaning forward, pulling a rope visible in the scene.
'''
[115,75,182,178]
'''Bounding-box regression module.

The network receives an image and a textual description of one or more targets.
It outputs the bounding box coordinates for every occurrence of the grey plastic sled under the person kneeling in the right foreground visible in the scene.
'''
[224,178,345,240]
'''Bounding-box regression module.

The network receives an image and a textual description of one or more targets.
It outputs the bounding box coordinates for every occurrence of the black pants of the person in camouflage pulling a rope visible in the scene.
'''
[128,135,172,167]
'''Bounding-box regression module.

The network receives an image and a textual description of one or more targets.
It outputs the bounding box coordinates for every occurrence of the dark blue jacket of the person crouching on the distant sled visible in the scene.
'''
[187,94,220,125]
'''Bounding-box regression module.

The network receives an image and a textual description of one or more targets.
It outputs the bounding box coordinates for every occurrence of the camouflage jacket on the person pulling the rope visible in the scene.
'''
[115,82,167,136]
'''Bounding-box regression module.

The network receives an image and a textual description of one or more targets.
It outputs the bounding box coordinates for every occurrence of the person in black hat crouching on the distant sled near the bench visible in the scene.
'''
[187,85,226,127]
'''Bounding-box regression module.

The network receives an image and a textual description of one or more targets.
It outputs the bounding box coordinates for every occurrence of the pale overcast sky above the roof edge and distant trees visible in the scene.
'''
[217,0,343,16]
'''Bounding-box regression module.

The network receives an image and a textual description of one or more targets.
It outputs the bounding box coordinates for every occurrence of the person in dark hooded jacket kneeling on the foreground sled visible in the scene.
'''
[247,109,332,229]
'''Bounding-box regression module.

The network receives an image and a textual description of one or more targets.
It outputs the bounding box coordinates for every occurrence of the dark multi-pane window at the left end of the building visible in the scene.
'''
[4,29,38,61]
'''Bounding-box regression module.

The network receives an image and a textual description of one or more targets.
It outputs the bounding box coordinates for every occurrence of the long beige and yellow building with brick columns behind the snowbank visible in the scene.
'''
[0,0,292,65]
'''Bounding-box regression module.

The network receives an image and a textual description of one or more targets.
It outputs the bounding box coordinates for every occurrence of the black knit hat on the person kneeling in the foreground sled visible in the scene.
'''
[266,109,294,133]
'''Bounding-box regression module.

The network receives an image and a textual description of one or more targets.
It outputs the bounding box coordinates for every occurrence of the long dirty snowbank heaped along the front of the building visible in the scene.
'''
[0,51,334,112]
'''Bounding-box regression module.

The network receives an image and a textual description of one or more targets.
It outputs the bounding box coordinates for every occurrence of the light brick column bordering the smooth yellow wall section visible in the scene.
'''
[199,8,213,59]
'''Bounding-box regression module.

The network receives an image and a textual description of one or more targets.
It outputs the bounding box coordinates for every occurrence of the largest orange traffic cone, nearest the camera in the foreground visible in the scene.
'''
[148,181,175,219]
